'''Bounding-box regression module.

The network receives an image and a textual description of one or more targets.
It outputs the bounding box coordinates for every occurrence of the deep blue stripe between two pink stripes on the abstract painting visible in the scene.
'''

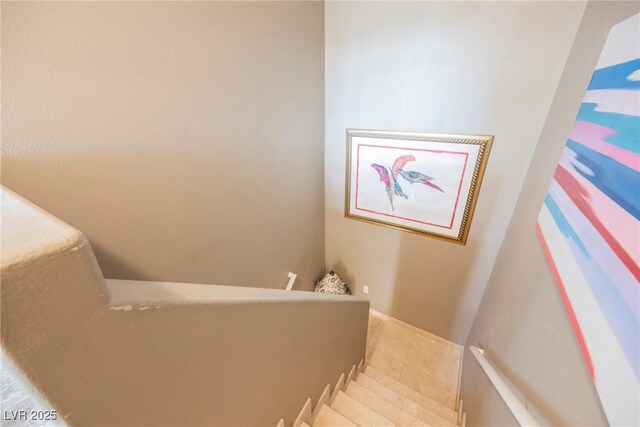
[567,139,640,219]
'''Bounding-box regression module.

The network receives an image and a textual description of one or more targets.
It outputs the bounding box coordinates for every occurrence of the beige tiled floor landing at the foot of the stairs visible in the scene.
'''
[366,314,462,408]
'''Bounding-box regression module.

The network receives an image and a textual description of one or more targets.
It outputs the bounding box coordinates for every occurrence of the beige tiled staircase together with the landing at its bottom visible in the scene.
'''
[277,316,465,427]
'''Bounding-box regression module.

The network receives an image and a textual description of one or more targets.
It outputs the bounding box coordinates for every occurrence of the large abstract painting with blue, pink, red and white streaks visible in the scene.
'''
[536,15,640,426]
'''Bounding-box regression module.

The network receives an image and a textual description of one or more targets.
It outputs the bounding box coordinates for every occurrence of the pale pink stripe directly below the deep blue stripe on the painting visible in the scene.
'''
[559,148,640,259]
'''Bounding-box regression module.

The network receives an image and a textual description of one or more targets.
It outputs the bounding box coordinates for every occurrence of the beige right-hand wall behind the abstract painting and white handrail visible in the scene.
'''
[462,2,640,426]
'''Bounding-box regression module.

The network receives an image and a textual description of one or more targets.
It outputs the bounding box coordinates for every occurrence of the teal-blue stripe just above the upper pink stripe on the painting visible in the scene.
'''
[577,103,640,153]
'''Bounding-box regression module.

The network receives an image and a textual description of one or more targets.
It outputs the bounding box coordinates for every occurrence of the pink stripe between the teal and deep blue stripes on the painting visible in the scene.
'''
[569,121,640,171]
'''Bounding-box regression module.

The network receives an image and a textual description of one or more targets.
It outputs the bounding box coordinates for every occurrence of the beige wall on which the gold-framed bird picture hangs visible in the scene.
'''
[325,2,585,344]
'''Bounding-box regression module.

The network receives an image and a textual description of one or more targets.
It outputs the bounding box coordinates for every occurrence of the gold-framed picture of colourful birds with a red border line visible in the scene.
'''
[345,129,493,245]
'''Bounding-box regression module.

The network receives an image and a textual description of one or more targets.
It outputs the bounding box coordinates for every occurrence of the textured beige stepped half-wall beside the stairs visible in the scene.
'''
[0,188,369,427]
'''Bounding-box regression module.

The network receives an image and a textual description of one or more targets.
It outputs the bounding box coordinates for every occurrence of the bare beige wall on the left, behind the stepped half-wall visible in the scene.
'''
[2,1,324,289]
